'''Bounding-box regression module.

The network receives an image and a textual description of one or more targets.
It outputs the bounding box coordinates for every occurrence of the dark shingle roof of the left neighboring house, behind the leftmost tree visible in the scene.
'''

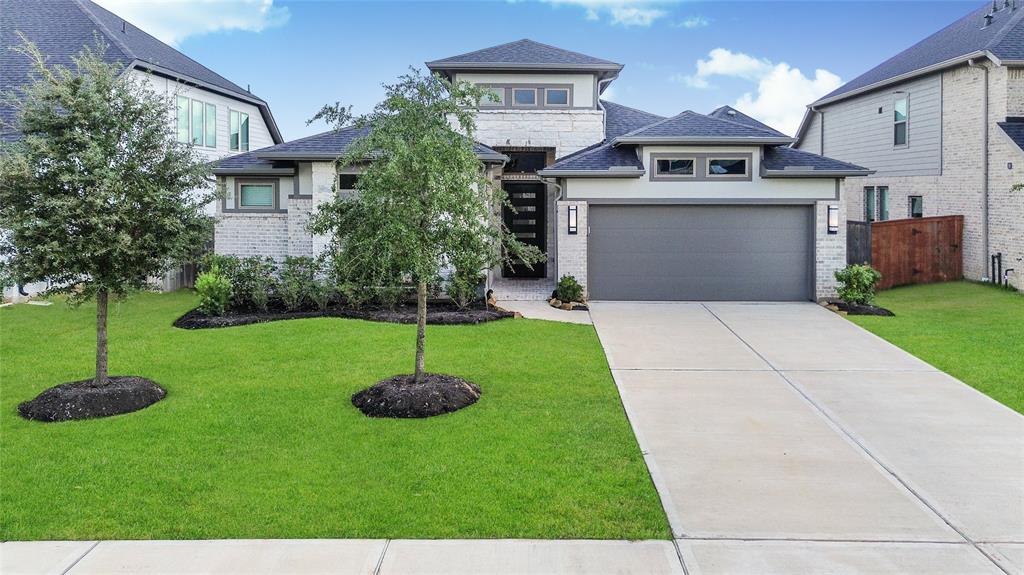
[0,0,283,142]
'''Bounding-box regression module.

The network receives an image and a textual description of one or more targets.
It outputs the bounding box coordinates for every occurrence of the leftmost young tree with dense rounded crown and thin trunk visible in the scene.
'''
[0,37,212,386]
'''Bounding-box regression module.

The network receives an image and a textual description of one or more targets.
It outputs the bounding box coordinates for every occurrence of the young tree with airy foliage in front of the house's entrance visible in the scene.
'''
[310,70,543,383]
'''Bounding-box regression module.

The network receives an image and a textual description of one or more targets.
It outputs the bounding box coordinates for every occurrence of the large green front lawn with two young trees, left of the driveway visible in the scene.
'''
[0,292,669,540]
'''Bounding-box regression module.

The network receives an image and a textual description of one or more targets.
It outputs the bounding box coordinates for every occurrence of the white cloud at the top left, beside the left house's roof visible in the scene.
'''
[96,0,291,46]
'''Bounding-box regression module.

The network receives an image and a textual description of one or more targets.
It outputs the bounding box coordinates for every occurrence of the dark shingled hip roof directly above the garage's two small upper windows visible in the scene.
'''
[611,109,794,145]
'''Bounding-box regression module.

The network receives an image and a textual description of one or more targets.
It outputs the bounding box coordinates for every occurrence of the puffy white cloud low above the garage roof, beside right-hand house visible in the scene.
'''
[670,48,843,134]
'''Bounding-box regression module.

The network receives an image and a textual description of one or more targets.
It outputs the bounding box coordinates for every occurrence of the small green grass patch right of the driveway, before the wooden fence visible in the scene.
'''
[850,281,1024,413]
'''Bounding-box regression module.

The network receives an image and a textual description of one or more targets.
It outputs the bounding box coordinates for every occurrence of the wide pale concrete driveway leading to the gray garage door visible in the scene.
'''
[591,302,1024,575]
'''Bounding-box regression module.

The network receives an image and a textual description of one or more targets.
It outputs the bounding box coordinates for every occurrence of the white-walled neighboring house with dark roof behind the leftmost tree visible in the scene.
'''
[0,0,284,288]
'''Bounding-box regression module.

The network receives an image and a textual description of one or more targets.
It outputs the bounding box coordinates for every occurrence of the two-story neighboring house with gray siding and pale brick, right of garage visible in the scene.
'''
[796,0,1024,288]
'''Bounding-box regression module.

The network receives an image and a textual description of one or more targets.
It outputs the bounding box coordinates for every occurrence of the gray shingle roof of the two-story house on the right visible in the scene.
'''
[815,0,1024,103]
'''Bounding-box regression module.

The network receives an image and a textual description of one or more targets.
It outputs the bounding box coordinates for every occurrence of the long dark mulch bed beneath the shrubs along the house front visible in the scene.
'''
[174,302,515,329]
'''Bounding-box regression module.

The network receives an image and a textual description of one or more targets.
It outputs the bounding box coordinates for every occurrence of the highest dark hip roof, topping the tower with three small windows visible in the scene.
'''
[426,39,623,74]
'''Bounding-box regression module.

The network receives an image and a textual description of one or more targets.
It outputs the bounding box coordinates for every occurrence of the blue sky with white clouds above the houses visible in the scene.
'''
[96,0,983,140]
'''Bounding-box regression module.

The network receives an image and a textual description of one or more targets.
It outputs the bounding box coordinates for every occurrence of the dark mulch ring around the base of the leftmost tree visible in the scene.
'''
[17,375,167,422]
